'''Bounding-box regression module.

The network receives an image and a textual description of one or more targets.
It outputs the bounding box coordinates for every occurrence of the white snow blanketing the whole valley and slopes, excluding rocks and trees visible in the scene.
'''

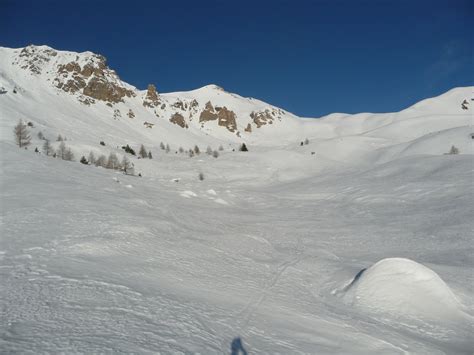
[0,49,474,354]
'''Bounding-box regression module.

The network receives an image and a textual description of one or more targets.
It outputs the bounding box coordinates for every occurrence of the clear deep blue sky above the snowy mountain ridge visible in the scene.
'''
[0,0,474,117]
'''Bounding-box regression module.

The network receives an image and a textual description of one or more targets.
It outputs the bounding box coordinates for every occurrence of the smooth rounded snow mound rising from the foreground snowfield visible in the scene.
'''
[344,258,461,320]
